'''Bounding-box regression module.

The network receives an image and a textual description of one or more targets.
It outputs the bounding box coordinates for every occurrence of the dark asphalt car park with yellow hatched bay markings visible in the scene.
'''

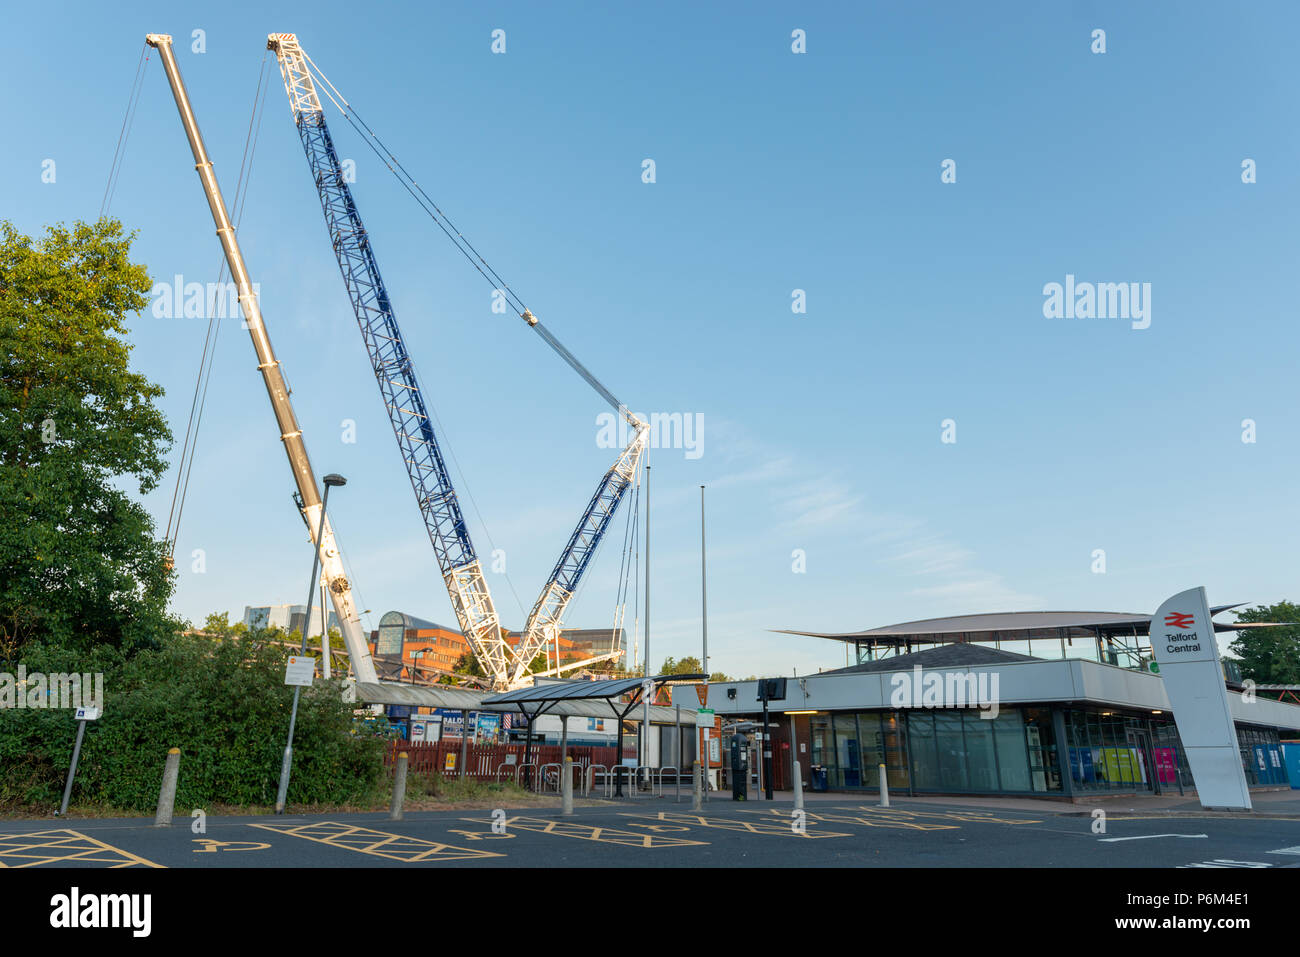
[0,792,1300,870]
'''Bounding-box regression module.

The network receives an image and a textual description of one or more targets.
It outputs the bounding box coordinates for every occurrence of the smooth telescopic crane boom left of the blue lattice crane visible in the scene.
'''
[144,34,378,683]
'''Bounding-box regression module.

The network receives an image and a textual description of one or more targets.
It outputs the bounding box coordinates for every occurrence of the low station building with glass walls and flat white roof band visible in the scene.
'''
[709,606,1300,800]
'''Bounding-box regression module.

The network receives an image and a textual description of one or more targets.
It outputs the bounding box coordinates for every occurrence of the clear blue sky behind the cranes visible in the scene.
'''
[0,3,1300,675]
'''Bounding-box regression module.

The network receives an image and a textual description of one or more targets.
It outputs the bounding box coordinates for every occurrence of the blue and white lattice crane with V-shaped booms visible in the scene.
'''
[267,34,649,688]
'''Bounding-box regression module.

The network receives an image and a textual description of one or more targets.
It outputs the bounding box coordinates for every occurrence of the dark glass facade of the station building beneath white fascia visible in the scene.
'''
[809,706,1287,796]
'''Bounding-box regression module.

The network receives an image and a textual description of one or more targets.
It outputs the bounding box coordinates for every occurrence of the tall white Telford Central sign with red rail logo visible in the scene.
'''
[1151,588,1251,810]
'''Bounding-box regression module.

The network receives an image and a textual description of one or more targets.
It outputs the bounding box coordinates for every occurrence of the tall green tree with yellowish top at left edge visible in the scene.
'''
[0,220,173,661]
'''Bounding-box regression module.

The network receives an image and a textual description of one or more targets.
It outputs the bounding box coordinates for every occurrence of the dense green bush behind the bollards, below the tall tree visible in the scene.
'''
[0,636,384,811]
